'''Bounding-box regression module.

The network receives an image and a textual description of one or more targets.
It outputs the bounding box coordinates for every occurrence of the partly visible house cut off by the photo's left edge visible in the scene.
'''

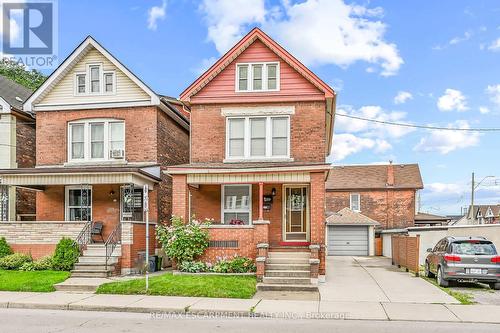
[0,75,36,222]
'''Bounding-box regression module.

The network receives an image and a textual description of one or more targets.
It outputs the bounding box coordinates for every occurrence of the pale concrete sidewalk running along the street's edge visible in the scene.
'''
[0,292,500,324]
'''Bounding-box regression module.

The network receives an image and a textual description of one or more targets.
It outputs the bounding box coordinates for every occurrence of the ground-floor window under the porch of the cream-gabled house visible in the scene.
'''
[66,185,92,221]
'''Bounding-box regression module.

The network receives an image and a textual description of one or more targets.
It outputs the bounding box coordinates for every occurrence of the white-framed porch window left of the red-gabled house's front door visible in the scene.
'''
[221,184,252,225]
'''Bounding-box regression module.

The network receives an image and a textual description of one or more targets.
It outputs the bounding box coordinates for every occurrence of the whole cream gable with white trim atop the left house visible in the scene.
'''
[24,36,160,111]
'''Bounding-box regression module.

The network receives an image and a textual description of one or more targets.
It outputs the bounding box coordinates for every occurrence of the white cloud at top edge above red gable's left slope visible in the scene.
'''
[200,0,267,54]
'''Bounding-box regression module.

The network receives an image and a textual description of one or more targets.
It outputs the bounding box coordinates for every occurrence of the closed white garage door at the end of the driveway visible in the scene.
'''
[327,225,368,256]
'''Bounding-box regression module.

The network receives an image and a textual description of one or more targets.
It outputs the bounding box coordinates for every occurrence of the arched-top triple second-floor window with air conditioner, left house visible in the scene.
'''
[68,119,125,162]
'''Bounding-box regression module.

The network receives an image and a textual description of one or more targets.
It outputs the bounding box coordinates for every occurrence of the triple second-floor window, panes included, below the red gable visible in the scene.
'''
[226,116,290,159]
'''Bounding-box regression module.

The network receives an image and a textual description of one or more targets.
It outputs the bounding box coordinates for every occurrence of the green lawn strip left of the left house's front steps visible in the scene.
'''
[0,270,69,292]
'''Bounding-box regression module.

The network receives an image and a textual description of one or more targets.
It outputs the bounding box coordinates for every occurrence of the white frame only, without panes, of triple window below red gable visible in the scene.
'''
[225,115,290,161]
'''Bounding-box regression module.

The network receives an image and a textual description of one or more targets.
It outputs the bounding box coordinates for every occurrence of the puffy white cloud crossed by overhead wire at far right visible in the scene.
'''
[413,120,480,154]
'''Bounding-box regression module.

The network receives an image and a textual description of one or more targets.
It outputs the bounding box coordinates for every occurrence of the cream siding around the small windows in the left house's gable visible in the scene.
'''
[36,49,151,105]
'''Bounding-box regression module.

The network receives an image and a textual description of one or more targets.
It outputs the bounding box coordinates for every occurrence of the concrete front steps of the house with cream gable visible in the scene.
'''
[71,244,121,278]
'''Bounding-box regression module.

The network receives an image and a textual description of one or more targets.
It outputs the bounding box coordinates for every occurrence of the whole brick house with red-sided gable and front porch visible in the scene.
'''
[166,28,335,288]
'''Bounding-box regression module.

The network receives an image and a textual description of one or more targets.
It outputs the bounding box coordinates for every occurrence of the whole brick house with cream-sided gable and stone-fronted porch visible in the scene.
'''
[0,37,189,277]
